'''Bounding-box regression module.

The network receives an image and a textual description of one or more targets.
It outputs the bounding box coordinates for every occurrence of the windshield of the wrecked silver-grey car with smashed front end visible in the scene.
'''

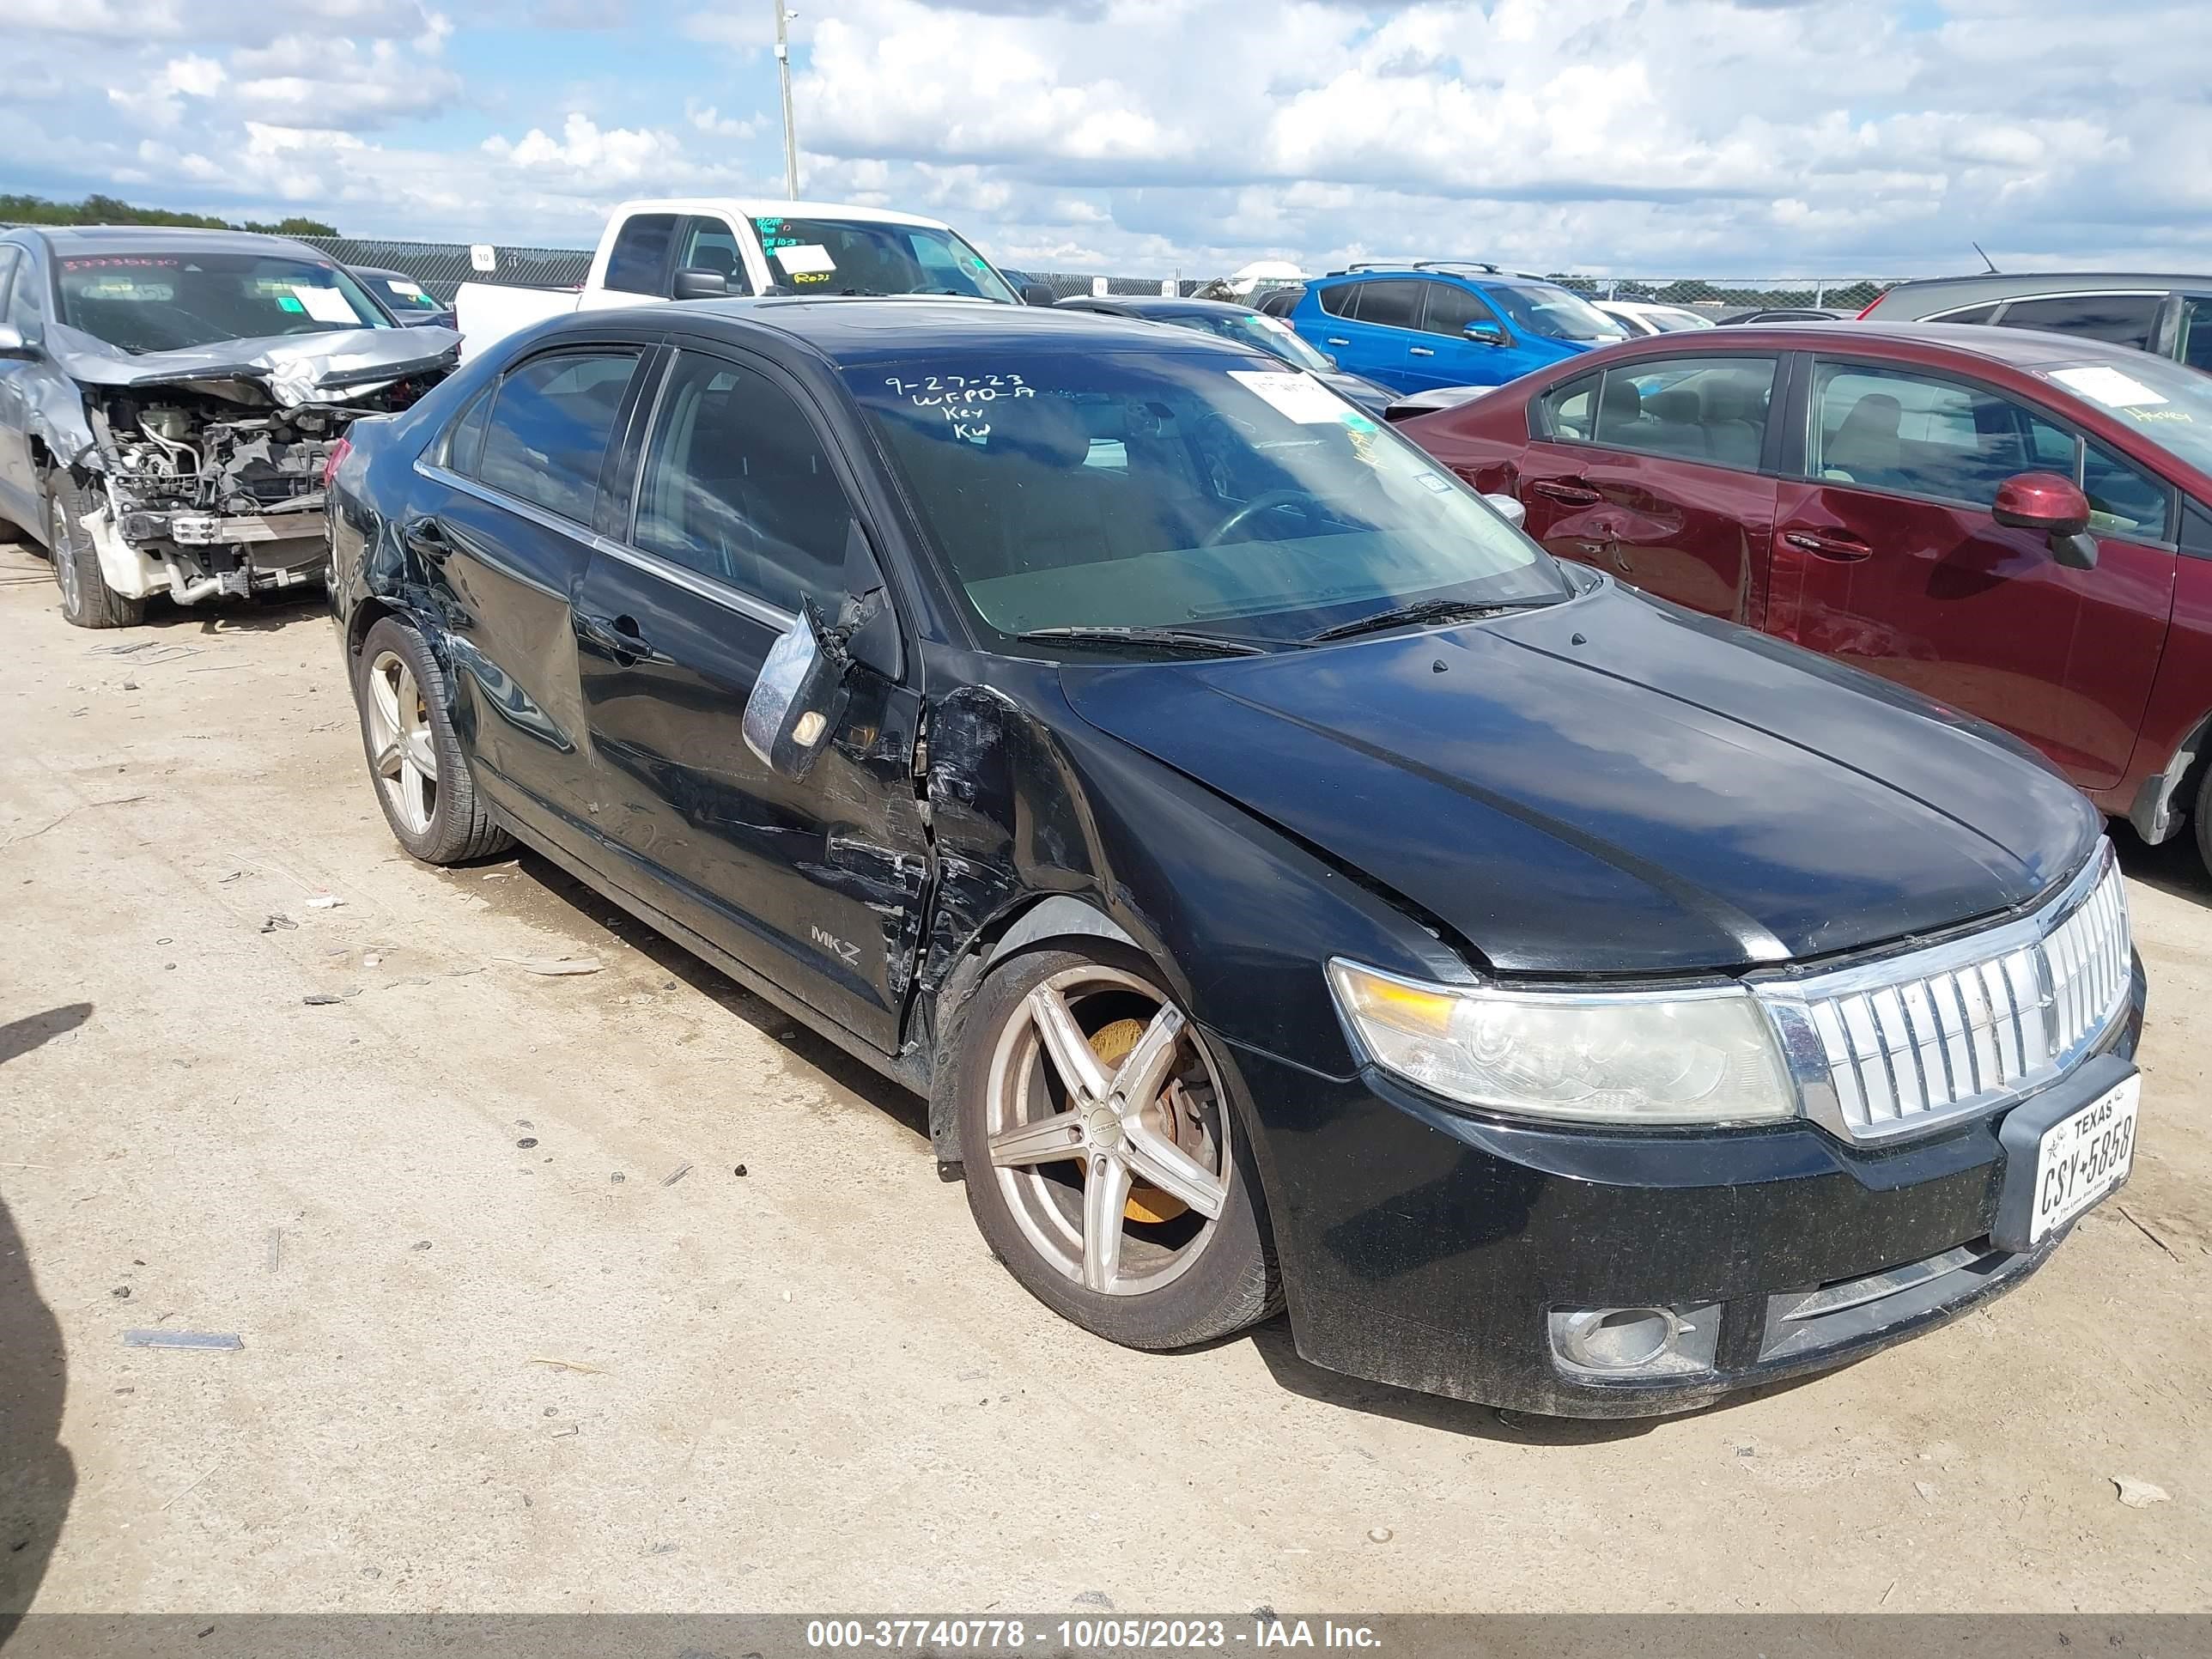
[60,252,392,354]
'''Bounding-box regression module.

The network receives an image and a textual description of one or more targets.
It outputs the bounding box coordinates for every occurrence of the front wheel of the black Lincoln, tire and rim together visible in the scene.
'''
[957,951,1279,1349]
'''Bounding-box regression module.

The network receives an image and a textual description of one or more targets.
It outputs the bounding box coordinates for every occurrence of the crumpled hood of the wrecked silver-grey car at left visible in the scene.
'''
[46,323,460,410]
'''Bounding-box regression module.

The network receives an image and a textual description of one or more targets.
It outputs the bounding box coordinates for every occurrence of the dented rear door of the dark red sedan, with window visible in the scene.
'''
[1517,352,1781,629]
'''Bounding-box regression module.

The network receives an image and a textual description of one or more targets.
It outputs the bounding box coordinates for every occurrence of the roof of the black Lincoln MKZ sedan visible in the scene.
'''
[650,295,1248,368]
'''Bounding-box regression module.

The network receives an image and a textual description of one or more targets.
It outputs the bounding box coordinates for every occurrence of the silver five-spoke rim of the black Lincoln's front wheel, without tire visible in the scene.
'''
[984,964,1230,1297]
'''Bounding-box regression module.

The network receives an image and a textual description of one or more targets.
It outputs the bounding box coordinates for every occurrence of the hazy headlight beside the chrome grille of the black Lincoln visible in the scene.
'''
[1329,960,1798,1124]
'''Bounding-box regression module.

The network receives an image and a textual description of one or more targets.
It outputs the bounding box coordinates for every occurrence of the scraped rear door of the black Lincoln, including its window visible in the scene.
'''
[416,338,648,858]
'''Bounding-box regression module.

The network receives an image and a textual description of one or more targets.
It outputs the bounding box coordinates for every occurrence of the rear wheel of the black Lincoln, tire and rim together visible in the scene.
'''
[354,617,508,865]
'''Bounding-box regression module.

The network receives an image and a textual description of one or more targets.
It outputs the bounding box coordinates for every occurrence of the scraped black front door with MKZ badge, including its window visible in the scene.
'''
[575,349,929,1051]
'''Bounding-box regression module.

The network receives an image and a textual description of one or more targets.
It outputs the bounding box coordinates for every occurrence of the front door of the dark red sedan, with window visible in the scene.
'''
[1767,358,2174,790]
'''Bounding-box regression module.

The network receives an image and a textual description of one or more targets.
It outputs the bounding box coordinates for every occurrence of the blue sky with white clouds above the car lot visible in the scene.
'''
[0,0,2212,276]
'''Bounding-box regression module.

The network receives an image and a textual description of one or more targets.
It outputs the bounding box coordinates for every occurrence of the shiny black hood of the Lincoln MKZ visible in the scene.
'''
[1061,581,2100,973]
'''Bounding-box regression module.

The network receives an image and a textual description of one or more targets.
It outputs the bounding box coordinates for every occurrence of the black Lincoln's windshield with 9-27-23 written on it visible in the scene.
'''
[845,347,1568,644]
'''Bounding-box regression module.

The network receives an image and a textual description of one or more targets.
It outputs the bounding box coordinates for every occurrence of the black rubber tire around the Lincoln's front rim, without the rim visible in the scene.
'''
[949,940,1283,1352]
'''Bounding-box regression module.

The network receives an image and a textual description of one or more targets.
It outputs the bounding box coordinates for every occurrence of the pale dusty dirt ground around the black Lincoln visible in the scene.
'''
[0,535,2212,1613]
